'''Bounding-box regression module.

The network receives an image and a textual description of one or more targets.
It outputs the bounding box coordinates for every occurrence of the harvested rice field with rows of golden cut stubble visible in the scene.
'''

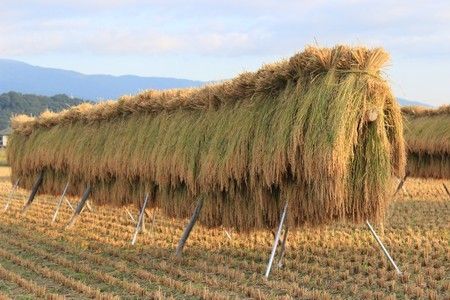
[0,167,450,299]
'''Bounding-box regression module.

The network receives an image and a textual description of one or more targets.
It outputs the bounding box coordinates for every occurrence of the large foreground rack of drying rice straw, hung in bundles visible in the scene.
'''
[8,46,405,231]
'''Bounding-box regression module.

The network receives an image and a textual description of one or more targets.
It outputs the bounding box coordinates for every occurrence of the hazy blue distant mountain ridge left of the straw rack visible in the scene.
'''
[0,59,204,101]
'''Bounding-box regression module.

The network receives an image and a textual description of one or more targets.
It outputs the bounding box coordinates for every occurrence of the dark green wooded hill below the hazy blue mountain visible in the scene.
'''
[0,92,85,130]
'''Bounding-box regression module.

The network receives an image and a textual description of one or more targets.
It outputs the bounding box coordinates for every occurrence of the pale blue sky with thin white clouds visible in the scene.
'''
[0,0,450,105]
